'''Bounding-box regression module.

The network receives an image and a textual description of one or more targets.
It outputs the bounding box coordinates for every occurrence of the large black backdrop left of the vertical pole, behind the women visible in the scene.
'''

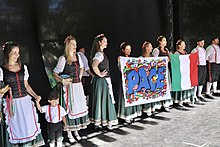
[0,0,169,97]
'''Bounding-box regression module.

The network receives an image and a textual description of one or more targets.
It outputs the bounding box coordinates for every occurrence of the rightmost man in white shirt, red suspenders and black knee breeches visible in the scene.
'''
[205,37,220,98]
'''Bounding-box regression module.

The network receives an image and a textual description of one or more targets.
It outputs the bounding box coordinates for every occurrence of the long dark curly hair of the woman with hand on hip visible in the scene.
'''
[90,34,106,63]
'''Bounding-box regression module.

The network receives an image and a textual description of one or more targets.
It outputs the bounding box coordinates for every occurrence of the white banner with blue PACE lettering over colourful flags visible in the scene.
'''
[120,57,171,107]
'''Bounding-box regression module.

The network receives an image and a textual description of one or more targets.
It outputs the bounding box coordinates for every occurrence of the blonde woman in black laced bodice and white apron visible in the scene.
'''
[53,35,90,143]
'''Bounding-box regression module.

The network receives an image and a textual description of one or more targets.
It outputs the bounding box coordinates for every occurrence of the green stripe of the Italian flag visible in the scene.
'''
[170,54,182,91]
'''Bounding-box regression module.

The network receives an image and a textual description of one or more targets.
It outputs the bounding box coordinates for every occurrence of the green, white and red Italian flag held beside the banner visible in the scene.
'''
[170,52,198,91]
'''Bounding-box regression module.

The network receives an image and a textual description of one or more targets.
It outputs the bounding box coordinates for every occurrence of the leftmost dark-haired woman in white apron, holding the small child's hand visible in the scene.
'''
[0,42,44,147]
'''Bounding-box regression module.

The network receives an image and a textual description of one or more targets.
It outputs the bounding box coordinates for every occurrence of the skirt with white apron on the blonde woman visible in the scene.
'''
[62,82,90,131]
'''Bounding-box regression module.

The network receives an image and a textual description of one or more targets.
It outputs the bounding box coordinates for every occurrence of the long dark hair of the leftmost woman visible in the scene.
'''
[2,41,21,67]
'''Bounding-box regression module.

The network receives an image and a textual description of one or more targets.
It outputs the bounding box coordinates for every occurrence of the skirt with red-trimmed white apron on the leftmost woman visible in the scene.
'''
[0,95,44,147]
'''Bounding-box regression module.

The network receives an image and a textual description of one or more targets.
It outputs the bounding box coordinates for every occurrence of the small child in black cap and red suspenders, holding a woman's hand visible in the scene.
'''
[36,91,67,147]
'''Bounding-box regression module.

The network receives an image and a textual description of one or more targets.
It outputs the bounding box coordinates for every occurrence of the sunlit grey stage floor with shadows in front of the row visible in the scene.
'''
[42,97,220,147]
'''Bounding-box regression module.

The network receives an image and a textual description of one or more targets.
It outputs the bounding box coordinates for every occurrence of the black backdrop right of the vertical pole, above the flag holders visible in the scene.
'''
[173,0,220,53]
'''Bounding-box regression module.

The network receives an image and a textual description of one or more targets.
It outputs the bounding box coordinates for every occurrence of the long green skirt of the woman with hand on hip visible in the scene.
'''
[89,76,118,126]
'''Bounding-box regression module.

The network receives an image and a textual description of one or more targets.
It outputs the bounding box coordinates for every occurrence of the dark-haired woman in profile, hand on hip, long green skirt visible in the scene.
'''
[89,34,118,129]
